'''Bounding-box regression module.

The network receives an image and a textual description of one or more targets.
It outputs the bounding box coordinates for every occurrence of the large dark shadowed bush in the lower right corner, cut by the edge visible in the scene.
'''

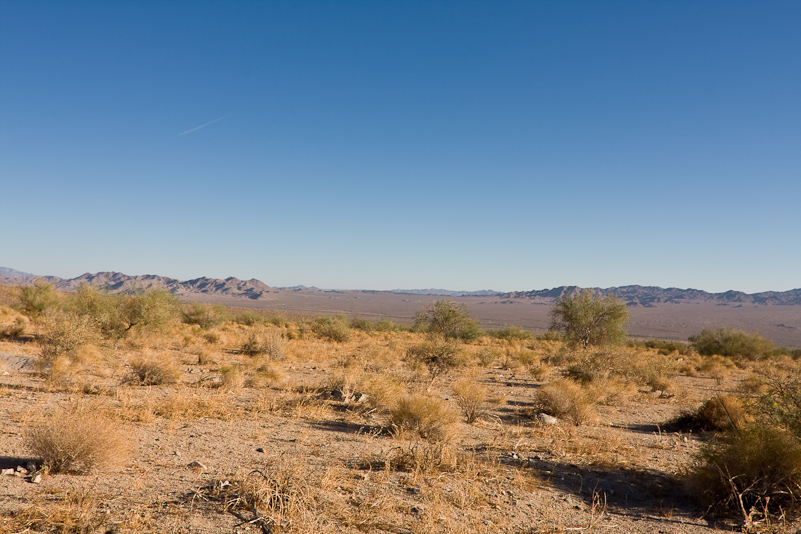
[689,425,801,526]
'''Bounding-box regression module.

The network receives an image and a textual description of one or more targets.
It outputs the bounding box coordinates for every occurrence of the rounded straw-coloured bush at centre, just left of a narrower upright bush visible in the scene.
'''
[389,394,458,441]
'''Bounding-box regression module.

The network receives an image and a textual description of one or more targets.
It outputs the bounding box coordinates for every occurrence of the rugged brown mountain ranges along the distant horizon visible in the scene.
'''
[0,267,801,307]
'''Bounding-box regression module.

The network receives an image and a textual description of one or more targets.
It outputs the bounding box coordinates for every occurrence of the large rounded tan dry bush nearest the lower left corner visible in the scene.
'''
[25,408,129,473]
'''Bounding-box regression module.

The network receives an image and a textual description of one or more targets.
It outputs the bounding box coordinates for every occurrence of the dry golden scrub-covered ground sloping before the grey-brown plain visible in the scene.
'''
[0,287,801,534]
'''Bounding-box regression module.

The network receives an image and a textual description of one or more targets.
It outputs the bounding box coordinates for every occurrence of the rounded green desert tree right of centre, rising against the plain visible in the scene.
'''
[550,289,629,348]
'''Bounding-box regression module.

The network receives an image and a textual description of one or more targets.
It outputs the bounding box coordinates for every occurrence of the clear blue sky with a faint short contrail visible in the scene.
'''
[0,0,801,292]
